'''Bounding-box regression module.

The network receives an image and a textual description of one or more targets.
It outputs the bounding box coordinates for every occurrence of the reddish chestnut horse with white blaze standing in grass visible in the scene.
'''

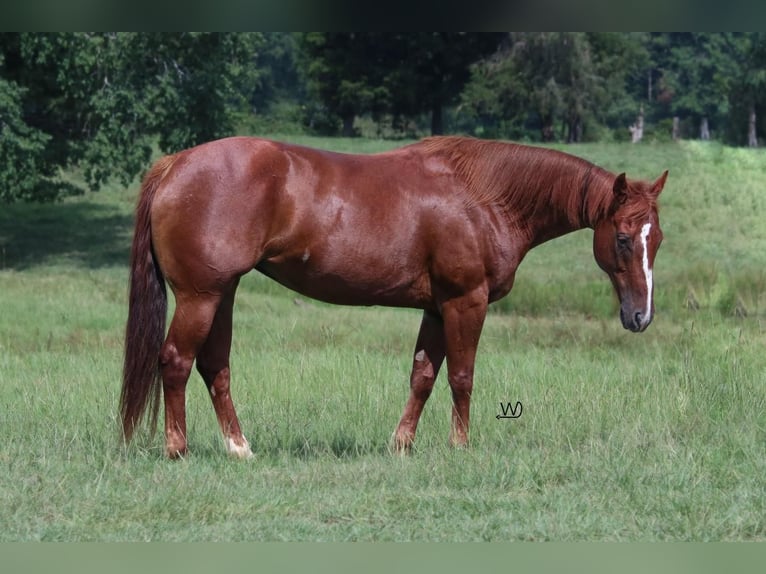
[120,136,668,458]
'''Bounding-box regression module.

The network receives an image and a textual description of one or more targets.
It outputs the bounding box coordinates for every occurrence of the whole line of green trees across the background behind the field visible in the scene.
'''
[0,32,766,201]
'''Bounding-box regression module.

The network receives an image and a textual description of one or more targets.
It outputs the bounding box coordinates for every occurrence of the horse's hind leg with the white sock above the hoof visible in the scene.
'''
[197,281,253,458]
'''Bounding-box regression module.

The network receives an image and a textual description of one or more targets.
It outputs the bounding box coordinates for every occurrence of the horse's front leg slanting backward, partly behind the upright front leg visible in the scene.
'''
[394,311,445,453]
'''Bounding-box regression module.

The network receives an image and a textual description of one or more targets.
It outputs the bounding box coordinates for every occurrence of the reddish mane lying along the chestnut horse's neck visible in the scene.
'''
[415,136,615,230]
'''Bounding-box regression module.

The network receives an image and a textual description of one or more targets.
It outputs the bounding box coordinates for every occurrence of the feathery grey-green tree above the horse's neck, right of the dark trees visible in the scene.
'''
[462,32,646,142]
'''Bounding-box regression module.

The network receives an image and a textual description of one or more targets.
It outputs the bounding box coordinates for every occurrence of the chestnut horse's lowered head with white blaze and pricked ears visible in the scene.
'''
[593,171,668,333]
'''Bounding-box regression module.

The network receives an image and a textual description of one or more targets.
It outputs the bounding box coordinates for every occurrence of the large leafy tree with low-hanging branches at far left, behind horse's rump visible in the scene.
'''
[0,33,261,199]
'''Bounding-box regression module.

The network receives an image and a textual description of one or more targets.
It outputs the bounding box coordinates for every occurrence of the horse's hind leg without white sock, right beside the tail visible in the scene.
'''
[160,293,221,458]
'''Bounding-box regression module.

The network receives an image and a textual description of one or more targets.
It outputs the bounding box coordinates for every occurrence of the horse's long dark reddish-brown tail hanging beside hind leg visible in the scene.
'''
[120,156,175,442]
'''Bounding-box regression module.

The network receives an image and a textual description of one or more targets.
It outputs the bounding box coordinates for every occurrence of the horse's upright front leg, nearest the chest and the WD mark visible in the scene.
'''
[442,287,489,447]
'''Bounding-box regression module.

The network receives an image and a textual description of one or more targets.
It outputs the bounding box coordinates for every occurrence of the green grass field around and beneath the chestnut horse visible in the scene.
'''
[0,138,766,541]
